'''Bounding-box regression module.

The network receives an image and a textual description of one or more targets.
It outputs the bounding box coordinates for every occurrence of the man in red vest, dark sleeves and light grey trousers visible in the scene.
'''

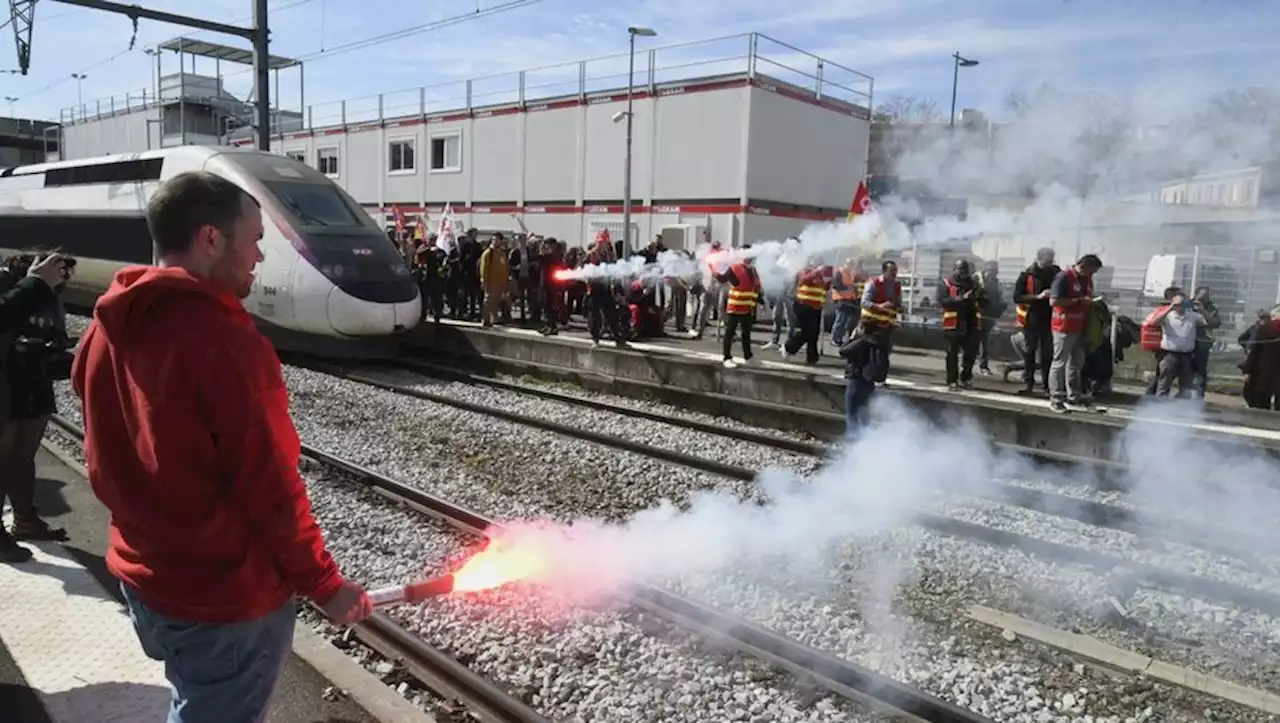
[1048,253,1102,413]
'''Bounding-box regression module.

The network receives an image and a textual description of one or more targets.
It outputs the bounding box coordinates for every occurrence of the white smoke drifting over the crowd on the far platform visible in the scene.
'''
[567,83,1280,301]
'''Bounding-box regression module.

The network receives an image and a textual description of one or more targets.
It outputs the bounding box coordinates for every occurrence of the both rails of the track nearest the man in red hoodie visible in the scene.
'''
[52,415,993,723]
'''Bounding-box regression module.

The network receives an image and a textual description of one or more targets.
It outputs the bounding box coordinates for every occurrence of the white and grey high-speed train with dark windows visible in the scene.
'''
[0,146,421,354]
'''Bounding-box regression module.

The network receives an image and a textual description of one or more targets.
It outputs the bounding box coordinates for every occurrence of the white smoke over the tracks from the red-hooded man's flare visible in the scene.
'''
[473,397,1280,609]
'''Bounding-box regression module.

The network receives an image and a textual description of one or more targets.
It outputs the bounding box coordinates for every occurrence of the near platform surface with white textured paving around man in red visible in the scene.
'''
[0,448,375,723]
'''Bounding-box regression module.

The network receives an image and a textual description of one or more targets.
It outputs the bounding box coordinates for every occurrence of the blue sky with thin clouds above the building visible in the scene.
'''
[0,0,1280,119]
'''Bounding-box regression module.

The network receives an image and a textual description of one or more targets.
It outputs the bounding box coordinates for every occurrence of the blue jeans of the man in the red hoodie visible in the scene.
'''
[120,582,297,723]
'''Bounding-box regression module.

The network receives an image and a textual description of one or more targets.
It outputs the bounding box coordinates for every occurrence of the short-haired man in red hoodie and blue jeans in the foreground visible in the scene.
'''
[72,171,371,723]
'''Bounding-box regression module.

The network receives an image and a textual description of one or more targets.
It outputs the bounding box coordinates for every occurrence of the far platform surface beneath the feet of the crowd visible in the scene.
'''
[424,319,1280,443]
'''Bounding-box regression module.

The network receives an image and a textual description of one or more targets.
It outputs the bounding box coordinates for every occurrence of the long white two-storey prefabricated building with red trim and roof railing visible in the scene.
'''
[52,33,872,244]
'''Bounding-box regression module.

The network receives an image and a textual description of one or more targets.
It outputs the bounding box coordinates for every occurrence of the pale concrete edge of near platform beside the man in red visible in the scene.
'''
[40,439,435,723]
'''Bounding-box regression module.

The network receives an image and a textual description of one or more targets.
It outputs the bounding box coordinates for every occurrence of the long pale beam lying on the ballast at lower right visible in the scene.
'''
[968,605,1280,715]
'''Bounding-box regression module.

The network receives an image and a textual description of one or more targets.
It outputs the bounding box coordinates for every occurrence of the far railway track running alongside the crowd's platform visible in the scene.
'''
[294,353,1280,616]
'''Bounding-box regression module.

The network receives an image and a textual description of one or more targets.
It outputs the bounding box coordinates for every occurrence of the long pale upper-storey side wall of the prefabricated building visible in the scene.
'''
[256,83,747,206]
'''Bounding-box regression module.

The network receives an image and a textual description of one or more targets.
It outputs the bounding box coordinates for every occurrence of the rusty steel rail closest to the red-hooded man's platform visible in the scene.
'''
[50,415,552,723]
